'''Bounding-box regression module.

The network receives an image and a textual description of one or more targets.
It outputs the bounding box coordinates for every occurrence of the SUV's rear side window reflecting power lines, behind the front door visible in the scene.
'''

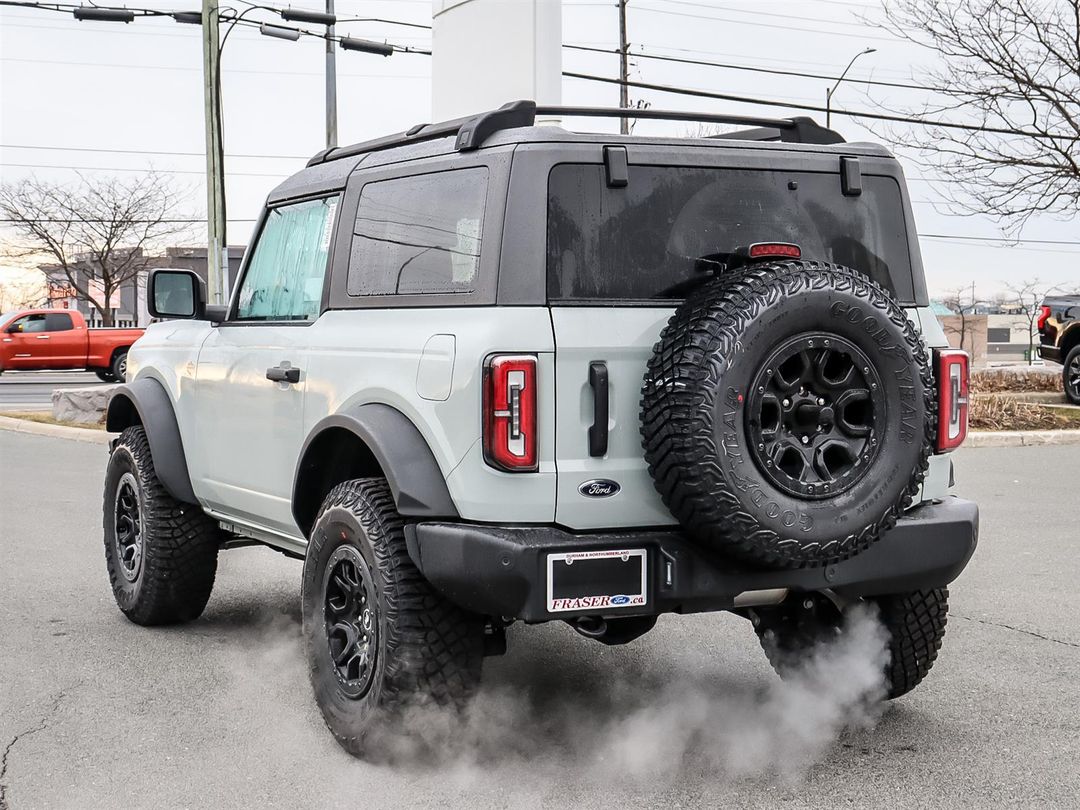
[346,166,487,296]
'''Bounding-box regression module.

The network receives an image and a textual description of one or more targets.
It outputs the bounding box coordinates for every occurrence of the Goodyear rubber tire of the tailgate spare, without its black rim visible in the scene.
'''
[642,261,935,568]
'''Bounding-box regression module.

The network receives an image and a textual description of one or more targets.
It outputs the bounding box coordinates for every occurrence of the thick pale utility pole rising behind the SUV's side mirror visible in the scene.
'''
[202,0,229,306]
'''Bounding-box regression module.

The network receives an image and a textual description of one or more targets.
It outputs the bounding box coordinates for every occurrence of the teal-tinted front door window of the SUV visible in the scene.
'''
[235,197,338,321]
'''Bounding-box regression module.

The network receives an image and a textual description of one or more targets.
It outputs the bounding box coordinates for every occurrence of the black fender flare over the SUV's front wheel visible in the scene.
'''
[105,377,199,504]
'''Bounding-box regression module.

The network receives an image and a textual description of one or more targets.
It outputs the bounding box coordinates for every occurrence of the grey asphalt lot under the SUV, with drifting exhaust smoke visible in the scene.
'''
[0,427,1080,810]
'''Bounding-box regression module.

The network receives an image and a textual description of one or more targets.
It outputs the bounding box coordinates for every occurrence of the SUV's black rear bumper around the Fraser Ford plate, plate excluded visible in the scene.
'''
[406,498,978,621]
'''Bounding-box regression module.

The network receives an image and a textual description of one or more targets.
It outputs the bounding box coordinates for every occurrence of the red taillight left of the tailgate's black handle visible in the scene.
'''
[484,354,537,472]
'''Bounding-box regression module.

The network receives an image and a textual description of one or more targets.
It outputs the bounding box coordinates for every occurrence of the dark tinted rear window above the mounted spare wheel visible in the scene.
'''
[548,164,914,302]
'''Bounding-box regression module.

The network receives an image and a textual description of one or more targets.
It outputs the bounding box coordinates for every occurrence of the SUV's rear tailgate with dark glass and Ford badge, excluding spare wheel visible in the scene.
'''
[546,157,914,529]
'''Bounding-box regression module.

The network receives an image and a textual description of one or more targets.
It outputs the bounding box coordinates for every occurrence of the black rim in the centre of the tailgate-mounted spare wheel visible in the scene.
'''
[746,333,886,500]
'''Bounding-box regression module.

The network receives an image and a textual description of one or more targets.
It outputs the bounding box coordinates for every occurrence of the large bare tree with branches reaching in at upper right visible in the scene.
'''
[885,0,1080,230]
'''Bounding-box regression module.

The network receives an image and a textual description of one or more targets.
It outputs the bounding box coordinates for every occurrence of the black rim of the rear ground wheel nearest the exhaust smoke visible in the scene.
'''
[323,545,379,700]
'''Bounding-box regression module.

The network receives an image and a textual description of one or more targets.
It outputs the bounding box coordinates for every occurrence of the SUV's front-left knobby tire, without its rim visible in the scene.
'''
[104,427,221,625]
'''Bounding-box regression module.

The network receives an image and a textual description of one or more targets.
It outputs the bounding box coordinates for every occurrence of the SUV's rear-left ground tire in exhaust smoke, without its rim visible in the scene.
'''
[302,478,484,760]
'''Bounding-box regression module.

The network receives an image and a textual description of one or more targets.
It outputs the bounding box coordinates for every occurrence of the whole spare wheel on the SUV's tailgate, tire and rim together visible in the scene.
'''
[642,261,935,568]
